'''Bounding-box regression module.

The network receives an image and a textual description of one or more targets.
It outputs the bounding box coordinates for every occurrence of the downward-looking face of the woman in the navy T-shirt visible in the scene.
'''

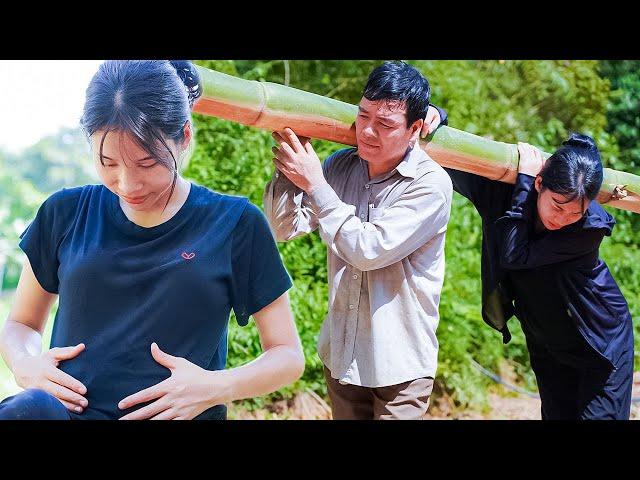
[91,131,178,211]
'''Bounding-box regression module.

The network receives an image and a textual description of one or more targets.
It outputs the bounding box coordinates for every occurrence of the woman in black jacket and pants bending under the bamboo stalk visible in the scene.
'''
[447,134,634,419]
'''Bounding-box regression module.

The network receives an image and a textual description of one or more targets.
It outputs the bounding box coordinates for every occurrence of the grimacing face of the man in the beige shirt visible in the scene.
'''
[356,97,422,172]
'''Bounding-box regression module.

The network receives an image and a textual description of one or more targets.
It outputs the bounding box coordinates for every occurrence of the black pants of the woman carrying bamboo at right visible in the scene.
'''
[527,336,633,420]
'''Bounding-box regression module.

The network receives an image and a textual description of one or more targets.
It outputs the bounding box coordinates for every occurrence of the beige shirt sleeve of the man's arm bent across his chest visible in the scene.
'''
[309,172,453,271]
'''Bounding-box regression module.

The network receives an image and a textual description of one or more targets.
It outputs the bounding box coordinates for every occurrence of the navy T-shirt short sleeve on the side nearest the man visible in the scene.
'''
[231,203,293,326]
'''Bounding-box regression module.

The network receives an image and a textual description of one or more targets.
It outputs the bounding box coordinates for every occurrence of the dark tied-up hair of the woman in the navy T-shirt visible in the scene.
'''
[80,60,202,207]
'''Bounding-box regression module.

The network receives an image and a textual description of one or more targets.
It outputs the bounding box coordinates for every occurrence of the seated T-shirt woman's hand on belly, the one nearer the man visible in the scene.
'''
[118,342,227,420]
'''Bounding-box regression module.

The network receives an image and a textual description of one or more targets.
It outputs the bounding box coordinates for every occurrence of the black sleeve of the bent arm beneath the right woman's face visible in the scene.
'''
[495,173,606,270]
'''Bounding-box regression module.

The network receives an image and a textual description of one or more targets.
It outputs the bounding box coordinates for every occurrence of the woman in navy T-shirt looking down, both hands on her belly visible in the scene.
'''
[0,61,304,419]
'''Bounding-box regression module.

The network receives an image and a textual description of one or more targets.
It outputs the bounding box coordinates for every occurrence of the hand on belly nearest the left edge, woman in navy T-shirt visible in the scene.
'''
[13,343,89,413]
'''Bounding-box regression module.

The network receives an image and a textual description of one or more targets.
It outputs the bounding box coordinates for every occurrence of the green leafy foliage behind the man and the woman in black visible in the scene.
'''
[185,60,640,406]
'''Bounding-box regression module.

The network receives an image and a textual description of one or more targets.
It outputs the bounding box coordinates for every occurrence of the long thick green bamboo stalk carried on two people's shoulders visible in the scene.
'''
[194,66,640,213]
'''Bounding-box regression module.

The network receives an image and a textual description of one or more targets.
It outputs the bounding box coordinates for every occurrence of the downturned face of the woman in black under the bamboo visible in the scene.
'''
[535,176,591,230]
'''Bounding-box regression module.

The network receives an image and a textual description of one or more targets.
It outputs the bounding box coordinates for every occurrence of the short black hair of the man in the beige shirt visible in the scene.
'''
[363,62,431,128]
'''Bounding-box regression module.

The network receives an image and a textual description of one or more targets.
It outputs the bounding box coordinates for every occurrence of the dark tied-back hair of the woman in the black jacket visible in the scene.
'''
[540,133,603,208]
